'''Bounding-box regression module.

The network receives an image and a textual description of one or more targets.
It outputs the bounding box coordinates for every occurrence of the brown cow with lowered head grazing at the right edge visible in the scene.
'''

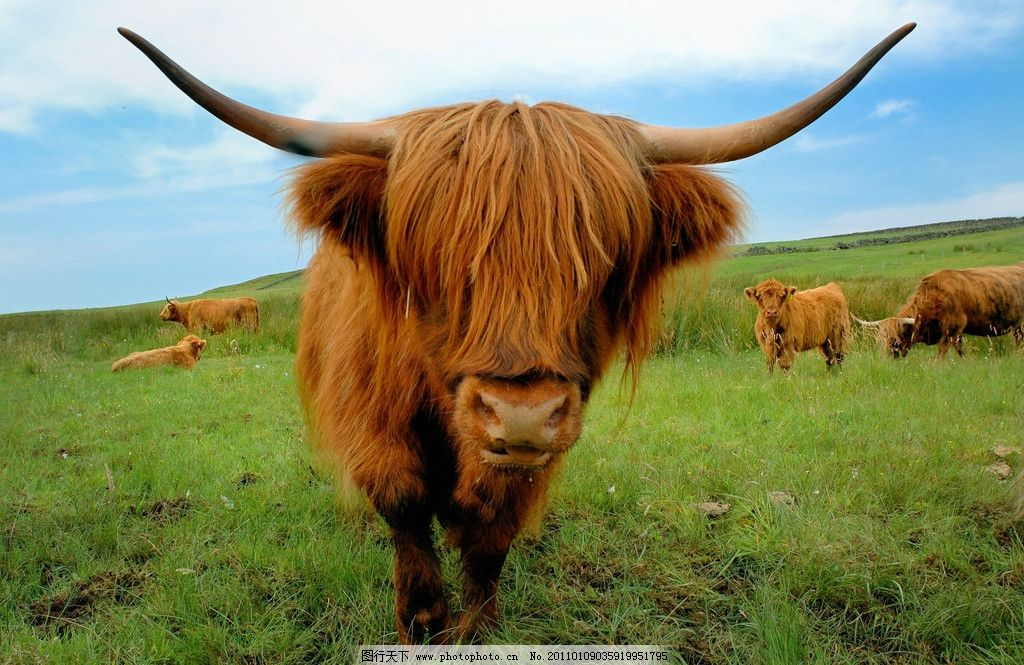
[857,263,1024,359]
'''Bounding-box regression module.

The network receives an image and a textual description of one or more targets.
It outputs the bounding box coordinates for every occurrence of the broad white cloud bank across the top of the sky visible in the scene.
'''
[0,0,1024,132]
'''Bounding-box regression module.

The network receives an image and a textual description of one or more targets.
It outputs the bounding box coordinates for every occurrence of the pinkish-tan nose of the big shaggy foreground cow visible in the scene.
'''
[477,389,569,450]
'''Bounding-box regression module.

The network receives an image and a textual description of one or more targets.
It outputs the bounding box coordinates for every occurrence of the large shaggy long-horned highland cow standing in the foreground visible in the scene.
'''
[122,25,913,641]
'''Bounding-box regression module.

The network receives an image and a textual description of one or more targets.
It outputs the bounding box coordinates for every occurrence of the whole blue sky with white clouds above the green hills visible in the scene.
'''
[0,0,1024,313]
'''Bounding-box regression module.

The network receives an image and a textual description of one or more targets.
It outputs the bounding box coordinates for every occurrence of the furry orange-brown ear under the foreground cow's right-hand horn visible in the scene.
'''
[647,164,743,263]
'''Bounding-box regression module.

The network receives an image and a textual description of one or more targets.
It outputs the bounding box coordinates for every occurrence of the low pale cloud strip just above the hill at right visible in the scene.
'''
[820,180,1024,235]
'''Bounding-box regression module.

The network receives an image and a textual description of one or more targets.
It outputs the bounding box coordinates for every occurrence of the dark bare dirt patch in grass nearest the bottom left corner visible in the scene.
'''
[30,571,148,632]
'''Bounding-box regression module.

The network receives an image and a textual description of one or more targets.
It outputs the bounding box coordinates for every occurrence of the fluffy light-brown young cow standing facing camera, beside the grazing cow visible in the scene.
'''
[743,280,850,374]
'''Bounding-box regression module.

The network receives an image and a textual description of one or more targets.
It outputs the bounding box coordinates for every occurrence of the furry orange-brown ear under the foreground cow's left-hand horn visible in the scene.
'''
[287,155,387,256]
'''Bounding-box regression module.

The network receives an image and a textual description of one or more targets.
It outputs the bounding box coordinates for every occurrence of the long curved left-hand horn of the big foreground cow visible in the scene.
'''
[118,28,394,157]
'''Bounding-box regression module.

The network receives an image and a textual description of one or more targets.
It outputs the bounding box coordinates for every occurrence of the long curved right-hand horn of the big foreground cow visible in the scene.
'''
[641,23,918,164]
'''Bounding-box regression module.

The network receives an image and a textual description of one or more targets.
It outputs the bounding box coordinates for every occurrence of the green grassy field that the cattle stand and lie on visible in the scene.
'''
[0,220,1024,663]
